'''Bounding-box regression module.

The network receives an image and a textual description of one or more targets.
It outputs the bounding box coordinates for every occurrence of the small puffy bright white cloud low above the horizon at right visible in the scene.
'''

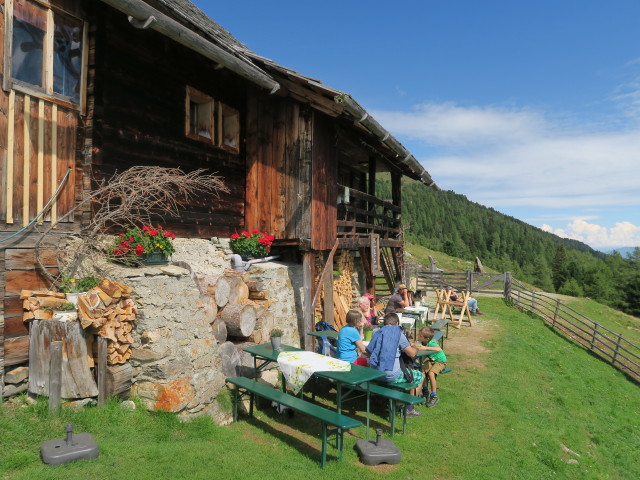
[540,219,640,248]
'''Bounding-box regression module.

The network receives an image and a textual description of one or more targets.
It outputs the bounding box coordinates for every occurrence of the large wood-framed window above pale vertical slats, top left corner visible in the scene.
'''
[5,0,85,105]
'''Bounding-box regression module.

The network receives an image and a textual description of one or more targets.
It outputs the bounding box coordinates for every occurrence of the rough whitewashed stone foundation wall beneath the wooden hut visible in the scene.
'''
[111,239,304,423]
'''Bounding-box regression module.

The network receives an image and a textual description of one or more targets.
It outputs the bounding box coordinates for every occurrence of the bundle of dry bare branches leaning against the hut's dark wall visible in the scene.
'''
[36,166,229,286]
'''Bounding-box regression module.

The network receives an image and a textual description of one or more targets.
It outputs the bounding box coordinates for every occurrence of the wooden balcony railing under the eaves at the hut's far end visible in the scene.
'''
[338,185,402,240]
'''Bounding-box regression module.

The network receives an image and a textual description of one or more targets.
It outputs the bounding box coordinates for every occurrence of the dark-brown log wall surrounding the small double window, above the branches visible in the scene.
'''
[93,6,253,237]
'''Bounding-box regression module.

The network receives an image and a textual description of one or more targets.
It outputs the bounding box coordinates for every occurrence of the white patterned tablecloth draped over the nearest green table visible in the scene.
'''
[278,351,351,394]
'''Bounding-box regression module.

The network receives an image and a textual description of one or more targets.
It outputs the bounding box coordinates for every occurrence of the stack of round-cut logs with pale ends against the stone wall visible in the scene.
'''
[197,271,274,376]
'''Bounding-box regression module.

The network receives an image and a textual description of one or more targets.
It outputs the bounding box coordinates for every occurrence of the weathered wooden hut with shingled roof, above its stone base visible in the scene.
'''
[0,0,433,394]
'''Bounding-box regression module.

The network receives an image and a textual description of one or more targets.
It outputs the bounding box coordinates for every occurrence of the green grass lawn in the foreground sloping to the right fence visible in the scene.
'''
[0,298,640,480]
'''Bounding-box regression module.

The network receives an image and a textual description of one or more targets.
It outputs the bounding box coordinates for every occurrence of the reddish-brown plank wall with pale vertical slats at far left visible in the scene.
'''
[0,0,83,376]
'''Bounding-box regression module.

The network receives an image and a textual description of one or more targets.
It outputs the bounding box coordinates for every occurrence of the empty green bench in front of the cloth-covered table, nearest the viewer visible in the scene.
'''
[227,377,362,468]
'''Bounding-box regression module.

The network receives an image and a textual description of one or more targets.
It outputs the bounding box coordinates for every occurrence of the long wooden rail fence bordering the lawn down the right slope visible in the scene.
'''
[406,264,640,382]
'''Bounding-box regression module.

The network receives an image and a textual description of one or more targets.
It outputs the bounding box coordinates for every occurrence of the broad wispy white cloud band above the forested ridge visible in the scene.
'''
[375,104,640,209]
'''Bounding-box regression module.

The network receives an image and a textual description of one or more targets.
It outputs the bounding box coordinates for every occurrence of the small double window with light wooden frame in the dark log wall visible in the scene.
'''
[185,86,240,153]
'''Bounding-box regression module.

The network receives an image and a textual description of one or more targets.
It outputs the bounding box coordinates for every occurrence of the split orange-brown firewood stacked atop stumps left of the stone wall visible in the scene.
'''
[20,279,138,365]
